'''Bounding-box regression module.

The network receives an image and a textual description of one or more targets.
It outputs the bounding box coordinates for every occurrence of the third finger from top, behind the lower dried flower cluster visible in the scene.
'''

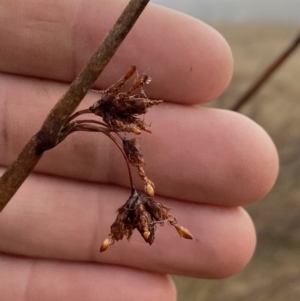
[0,170,255,278]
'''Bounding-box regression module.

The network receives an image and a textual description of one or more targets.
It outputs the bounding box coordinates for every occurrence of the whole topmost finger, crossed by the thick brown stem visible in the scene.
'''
[0,0,232,103]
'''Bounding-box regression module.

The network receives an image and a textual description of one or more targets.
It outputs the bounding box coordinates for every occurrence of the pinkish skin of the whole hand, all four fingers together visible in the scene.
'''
[0,0,278,301]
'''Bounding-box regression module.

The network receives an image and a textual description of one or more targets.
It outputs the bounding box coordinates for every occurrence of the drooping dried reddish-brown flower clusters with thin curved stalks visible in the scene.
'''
[60,66,192,252]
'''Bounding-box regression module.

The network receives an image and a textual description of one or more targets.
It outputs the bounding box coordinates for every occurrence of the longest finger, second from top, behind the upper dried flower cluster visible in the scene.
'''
[0,75,278,205]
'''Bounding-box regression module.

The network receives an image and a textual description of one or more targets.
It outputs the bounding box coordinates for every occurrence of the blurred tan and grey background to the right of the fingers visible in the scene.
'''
[152,0,300,301]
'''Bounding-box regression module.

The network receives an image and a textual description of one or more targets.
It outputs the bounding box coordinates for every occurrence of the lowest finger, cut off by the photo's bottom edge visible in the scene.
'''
[0,255,176,301]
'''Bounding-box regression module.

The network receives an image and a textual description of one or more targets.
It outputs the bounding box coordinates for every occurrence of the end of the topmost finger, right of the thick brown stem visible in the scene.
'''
[101,4,233,104]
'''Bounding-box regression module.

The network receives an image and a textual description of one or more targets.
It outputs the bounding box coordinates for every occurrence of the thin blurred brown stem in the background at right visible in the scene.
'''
[231,32,300,111]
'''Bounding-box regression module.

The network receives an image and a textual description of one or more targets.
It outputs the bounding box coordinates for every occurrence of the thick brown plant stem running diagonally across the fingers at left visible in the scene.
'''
[0,0,150,212]
